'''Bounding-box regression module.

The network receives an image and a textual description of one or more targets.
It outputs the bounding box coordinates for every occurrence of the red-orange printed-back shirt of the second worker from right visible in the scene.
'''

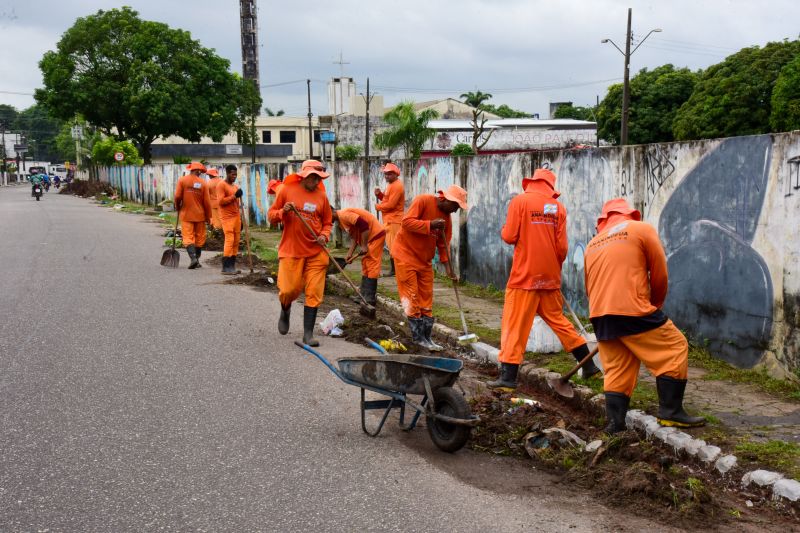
[500,181,569,290]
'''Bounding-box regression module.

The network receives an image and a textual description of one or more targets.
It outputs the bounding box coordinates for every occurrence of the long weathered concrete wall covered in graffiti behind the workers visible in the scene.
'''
[98,132,800,372]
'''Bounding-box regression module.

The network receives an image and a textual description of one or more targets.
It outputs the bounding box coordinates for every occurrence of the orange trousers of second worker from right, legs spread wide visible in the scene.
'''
[498,288,586,365]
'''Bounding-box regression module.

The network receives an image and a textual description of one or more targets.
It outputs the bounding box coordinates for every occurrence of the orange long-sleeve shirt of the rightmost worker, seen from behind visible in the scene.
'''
[584,214,668,318]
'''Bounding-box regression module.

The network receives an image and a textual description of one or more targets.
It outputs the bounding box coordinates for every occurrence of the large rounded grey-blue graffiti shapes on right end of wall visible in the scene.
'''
[659,135,773,368]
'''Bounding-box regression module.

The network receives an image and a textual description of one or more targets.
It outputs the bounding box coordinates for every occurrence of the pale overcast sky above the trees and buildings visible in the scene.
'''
[0,0,800,118]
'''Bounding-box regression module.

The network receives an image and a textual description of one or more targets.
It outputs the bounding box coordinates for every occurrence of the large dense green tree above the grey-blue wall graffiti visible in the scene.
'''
[673,41,800,140]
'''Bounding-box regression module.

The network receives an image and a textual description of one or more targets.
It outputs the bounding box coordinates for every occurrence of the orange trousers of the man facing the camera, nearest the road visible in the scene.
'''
[278,251,329,307]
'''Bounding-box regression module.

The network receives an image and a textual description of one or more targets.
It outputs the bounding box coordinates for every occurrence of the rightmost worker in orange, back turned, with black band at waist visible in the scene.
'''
[584,198,705,433]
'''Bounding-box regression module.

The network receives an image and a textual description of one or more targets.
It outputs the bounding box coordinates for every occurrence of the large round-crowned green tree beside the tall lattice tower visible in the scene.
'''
[36,7,260,163]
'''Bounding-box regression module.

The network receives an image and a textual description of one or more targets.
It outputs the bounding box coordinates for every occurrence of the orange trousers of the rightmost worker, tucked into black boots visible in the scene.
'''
[600,320,689,397]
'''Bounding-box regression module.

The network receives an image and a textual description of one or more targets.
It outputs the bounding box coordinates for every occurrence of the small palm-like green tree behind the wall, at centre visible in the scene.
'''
[373,102,439,159]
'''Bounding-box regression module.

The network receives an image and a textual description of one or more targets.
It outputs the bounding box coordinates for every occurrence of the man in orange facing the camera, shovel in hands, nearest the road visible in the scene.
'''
[269,159,333,346]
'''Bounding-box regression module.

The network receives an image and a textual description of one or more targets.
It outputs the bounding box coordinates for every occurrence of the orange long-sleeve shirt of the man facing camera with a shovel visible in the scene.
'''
[268,183,333,258]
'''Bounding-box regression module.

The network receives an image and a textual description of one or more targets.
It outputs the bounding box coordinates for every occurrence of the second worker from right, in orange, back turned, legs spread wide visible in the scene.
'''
[489,168,600,389]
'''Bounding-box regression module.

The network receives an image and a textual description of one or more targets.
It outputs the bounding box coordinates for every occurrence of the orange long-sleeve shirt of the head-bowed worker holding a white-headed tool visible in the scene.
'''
[391,194,453,269]
